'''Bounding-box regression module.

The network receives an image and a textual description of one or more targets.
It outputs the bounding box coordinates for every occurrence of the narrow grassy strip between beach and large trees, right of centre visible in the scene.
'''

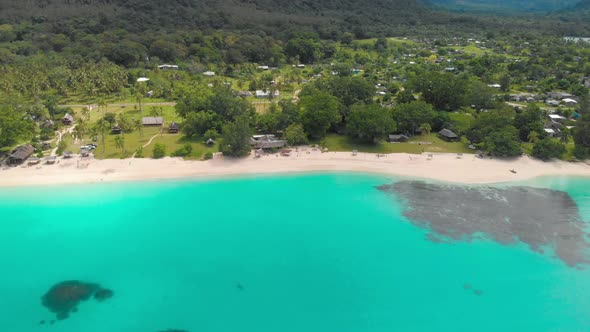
[315,134,473,154]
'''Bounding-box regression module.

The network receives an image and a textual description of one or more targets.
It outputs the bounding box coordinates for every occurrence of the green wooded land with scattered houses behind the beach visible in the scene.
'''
[0,0,590,159]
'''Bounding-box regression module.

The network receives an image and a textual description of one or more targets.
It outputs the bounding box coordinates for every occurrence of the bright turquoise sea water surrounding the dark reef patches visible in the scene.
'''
[0,174,590,332]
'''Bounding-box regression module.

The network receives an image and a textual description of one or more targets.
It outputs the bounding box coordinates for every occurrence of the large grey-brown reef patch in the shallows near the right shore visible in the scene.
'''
[378,181,589,266]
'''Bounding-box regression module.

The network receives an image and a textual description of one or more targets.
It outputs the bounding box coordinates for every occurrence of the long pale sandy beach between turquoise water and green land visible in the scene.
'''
[0,149,590,187]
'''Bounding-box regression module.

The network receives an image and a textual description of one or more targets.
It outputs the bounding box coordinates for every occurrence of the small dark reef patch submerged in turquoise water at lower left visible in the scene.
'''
[41,280,113,322]
